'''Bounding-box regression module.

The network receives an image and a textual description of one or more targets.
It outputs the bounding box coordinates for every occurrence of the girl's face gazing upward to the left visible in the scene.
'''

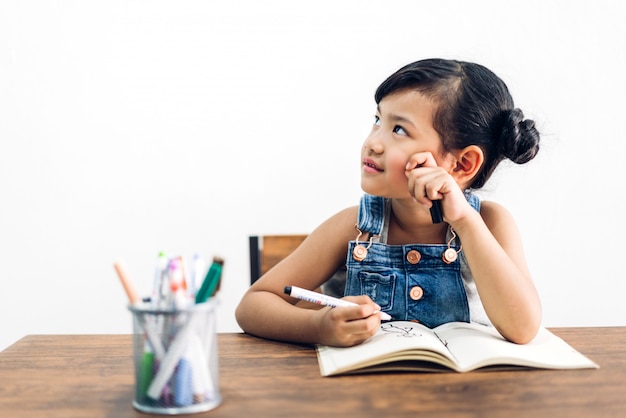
[361,90,452,198]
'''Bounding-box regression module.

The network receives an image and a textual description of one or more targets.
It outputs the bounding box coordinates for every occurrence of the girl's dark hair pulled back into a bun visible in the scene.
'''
[374,58,539,189]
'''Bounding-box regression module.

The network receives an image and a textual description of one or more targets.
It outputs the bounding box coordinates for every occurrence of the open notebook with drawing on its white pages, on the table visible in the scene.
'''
[317,321,598,376]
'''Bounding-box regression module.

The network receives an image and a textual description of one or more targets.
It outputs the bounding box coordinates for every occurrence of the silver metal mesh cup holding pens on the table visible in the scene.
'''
[128,298,222,415]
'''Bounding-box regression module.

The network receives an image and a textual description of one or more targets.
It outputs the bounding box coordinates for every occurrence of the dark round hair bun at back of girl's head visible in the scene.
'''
[500,108,539,164]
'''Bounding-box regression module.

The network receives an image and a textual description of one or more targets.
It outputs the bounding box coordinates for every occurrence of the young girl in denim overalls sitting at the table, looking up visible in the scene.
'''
[236,59,541,346]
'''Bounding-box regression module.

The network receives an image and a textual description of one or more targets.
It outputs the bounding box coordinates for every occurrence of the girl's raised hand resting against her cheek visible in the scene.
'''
[405,152,471,224]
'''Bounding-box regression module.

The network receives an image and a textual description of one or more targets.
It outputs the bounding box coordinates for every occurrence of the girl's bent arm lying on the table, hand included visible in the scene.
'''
[235,207,380,346]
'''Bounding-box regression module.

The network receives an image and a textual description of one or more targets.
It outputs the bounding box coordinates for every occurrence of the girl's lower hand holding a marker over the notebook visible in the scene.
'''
[317,296,380,347]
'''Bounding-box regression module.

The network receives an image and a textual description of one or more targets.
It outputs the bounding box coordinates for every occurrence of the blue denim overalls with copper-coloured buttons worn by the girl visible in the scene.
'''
[345,193,480,328]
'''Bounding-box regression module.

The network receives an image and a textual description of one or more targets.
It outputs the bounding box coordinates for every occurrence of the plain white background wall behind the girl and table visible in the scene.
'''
[0,0,626,349]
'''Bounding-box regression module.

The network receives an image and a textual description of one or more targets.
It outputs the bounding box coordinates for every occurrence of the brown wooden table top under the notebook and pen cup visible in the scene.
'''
[0,327,626,418]
